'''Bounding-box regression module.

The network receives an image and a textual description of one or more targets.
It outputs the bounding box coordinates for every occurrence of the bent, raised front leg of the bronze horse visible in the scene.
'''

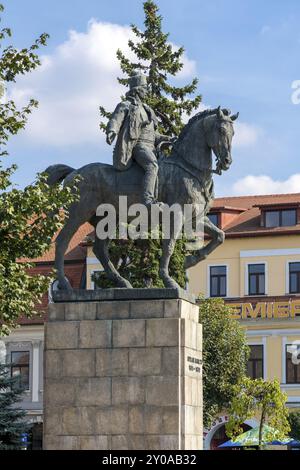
[185,216,225,269]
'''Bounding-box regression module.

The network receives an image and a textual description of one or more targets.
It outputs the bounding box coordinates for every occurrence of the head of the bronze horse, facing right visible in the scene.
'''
[203,107,239,173]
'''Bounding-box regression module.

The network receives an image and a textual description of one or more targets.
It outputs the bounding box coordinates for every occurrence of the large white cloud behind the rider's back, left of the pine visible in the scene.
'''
[10,20,195,146]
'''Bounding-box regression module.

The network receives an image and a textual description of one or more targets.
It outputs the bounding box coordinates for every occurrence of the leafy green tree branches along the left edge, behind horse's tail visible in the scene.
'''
[0,5,75,335]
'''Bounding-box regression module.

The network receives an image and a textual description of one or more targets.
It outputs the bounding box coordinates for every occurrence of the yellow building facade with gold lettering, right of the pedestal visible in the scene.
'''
[189,235,300,396]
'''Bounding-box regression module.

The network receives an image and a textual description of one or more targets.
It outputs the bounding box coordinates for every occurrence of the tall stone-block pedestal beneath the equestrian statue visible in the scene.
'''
[44,289,202,450]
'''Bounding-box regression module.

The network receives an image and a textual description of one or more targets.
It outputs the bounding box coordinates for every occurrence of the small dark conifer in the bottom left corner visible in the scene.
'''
[0,364,29,450]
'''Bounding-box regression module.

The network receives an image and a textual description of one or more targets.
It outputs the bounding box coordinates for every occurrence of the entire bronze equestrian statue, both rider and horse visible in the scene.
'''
[46,93,238,290]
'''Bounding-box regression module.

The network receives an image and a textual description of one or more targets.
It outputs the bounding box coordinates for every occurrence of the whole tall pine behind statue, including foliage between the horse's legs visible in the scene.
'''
[96,0,201,288]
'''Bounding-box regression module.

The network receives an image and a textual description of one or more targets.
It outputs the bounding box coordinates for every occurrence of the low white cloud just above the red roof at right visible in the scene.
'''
[232,173,300,196]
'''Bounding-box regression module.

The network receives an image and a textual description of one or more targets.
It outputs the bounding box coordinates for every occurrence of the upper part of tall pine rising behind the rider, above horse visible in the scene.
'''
[100,0,201,136]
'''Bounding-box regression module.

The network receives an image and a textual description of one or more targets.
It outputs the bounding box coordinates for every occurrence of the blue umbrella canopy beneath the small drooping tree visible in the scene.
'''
[219,424,297,448]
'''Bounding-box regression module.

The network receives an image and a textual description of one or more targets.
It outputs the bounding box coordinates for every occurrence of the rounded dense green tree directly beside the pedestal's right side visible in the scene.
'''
[199,299,249,427]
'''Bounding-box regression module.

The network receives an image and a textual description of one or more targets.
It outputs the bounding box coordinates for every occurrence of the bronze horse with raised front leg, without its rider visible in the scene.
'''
[46,108,238,290]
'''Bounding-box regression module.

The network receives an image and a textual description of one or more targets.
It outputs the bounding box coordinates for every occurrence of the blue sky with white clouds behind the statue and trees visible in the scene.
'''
[2,0,300,195]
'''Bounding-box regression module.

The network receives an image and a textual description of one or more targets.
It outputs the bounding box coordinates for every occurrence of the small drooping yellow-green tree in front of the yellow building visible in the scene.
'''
[226,377,290,448]
